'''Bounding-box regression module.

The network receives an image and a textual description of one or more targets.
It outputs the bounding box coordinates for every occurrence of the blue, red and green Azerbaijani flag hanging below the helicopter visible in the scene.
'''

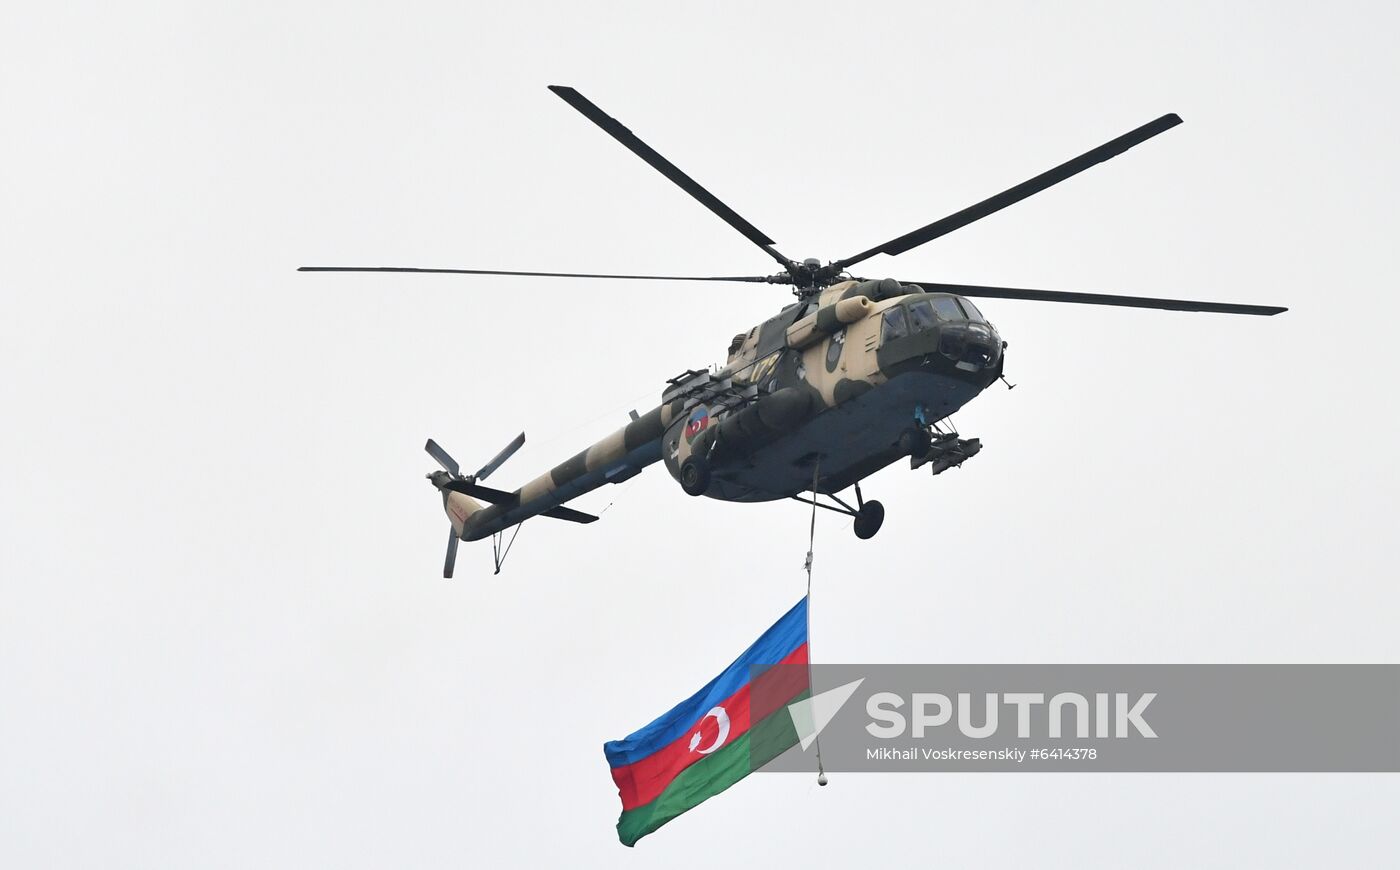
[603,598,808,846]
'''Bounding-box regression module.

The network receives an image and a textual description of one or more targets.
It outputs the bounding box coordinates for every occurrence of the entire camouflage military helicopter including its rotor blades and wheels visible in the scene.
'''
[300,85,1287,577]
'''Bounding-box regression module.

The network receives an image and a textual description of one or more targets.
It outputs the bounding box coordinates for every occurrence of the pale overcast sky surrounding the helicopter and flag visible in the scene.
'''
[0,1,1400,867]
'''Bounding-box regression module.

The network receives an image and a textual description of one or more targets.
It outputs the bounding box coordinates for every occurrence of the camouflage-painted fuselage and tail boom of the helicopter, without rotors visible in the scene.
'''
[447,280,1004,541]
